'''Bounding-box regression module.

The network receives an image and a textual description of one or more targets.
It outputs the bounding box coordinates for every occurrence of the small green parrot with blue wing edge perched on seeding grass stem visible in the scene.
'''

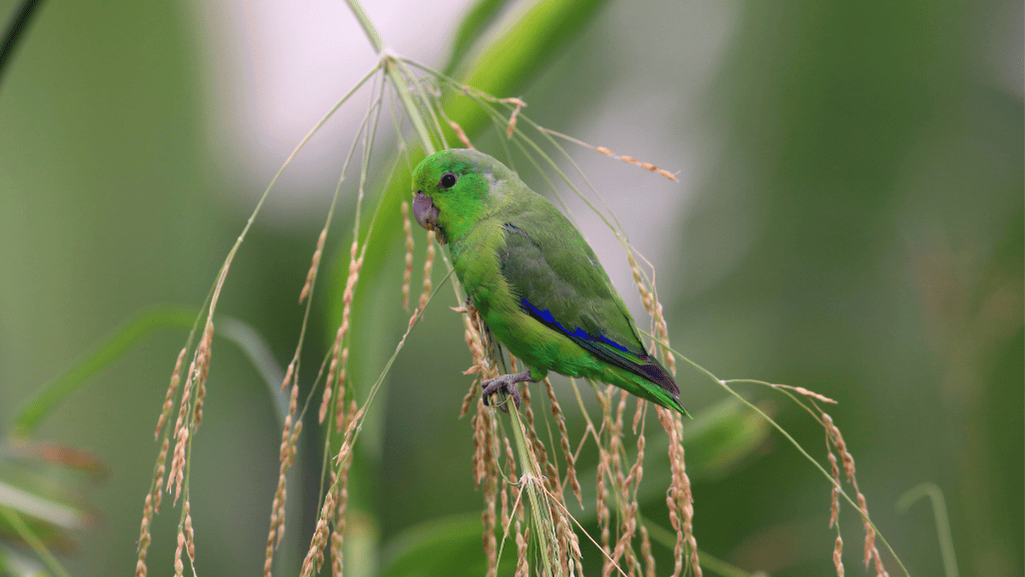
[413,149,687,415]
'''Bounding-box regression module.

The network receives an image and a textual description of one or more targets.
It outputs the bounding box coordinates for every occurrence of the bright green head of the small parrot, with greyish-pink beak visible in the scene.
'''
[413,149,511,243]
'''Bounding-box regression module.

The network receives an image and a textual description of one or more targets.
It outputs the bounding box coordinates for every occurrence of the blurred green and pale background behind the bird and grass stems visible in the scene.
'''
[0,0,1025,576]
